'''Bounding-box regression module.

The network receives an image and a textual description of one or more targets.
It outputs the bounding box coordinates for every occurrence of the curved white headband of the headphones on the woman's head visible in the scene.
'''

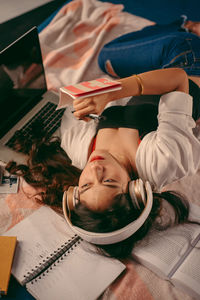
[63,181,153,245]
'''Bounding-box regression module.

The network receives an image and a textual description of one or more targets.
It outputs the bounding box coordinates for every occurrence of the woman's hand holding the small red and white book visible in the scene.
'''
[73,93,112,120]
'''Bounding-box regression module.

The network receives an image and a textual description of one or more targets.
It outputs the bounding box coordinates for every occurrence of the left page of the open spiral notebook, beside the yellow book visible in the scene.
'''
[5,206,73,284]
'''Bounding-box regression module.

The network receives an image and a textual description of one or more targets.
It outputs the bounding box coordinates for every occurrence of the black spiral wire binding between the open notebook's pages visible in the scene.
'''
[22,234,82,285]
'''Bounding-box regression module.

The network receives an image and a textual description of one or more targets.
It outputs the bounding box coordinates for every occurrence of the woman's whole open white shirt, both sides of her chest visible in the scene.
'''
[61,92,200,191]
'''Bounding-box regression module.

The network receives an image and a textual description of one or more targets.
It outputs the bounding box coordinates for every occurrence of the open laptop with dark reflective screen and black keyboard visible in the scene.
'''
[0,27,64,162]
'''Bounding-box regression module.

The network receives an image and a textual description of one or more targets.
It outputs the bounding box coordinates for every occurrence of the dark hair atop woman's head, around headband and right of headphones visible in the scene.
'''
[71,191,189,258]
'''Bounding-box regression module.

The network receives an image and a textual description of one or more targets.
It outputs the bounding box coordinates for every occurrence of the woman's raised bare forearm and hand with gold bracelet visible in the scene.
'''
[73,68,189,119]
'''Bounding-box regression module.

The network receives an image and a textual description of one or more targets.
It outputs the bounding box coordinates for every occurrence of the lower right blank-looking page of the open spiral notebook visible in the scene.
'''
[26,242,125,300]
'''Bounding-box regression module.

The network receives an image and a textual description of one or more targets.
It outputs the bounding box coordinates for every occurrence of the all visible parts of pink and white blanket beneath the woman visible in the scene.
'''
[0,0,200,300]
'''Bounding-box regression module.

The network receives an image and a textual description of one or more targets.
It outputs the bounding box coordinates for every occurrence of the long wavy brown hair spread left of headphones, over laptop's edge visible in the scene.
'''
[6,137,81,211]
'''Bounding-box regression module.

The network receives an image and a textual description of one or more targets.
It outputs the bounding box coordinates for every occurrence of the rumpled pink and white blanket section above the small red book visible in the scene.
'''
[40,0,153,89]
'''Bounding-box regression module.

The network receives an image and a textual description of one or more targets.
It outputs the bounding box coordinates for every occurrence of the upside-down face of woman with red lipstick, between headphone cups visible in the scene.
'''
[79,150,130,211]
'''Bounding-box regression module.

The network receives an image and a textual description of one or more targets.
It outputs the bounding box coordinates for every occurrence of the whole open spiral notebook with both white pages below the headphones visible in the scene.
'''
[5,206,125,300]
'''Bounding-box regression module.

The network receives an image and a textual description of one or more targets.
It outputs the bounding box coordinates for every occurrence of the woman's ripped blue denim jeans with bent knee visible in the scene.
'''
[98,19,200,77]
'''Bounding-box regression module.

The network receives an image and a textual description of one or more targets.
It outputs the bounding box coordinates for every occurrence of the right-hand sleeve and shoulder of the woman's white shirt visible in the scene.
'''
[136,92,200,191]
